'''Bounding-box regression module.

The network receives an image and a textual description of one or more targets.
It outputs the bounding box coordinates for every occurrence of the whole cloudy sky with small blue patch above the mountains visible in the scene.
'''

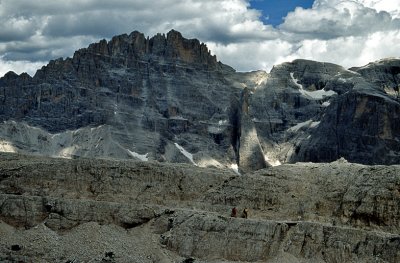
[0,0,400,76]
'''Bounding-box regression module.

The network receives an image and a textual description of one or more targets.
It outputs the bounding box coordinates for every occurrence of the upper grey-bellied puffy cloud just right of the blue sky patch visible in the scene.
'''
[280,0,400,39]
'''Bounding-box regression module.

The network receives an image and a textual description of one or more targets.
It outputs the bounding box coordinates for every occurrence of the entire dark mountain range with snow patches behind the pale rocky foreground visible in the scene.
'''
[0,30,400,172]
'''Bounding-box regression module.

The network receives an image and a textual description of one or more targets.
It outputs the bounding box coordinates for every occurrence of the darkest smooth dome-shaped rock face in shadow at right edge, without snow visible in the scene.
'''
[294,87,400,164]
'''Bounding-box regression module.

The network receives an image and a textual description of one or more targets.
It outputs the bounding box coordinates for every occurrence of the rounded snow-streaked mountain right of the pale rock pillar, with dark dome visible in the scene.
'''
[250,60,400,164]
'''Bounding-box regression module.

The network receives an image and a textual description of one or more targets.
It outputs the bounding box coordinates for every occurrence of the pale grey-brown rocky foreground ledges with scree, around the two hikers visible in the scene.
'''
[0,154,400,262]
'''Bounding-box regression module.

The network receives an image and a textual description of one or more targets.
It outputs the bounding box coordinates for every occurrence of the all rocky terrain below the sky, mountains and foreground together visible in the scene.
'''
[0,30,400,263]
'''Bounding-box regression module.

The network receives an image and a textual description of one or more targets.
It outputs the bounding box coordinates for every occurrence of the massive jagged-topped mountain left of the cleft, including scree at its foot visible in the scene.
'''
[0,30,247,167]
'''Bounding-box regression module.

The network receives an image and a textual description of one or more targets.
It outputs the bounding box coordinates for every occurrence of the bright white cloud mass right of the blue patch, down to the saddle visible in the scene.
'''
[212,0,400,71]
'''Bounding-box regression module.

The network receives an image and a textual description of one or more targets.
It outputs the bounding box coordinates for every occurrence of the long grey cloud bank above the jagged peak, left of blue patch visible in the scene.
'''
[0,0,279,74]
